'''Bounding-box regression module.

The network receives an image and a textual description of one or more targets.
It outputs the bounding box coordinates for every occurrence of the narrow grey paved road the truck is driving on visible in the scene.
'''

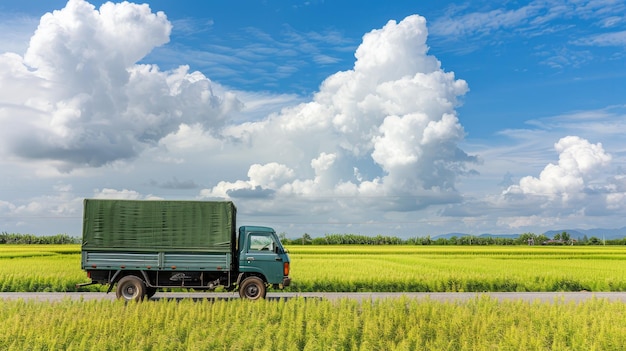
[0,292,626,302]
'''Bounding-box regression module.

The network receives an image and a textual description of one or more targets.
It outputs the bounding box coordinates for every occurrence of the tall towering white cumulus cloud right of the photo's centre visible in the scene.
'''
[203,16,475,211]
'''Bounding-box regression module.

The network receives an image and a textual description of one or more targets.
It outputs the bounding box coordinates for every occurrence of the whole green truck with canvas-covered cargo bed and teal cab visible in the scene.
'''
[79,199,291,301]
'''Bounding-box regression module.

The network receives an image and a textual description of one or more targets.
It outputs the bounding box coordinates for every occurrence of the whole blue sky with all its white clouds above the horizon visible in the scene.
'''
[0,0,626,237]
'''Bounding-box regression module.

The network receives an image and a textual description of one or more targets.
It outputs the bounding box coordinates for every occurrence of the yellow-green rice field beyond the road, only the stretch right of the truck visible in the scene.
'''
[291,246,626,292]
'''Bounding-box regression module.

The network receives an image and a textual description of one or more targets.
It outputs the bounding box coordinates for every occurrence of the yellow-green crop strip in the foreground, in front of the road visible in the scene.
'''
[0,297,626,351]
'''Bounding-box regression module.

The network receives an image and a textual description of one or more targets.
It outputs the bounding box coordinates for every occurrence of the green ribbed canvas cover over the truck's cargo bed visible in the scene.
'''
[83,199,237,252]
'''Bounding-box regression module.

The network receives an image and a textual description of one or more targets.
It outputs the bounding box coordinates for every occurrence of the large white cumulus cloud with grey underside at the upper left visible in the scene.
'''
[0,0,241,171]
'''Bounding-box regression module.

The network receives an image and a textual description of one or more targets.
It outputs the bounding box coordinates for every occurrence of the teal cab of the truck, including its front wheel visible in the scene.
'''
[238,226,291,299]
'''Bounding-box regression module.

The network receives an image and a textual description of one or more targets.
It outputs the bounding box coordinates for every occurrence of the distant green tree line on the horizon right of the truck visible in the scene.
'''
[279,232,626,245]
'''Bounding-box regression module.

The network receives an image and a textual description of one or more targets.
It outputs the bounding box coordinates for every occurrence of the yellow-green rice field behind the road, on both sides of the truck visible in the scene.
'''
[0,245,626,292]
